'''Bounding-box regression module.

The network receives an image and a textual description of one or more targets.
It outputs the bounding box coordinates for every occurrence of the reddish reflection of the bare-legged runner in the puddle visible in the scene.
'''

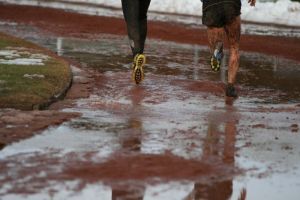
[185,111,246,200]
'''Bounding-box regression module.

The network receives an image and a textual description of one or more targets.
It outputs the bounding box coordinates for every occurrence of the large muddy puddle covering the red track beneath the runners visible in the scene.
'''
[0,23,300,200]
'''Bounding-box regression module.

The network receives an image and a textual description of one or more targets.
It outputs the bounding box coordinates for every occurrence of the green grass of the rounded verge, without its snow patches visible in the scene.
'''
[0,33,71,110]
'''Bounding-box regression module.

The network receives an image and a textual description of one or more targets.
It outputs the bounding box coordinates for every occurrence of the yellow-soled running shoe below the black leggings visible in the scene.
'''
[132,54,146,84]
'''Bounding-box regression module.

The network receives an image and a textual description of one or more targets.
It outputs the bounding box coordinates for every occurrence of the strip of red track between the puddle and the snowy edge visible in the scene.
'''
[0,5,300,61]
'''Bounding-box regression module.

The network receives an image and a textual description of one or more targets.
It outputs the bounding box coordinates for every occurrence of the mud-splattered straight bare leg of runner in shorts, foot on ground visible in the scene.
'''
[225,16,241,84]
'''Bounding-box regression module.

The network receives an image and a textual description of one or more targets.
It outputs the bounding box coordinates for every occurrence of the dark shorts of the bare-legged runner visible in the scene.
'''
[202,0,241,27]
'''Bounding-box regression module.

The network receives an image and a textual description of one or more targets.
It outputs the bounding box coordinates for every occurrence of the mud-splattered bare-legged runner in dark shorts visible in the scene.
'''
[202,0,256,97]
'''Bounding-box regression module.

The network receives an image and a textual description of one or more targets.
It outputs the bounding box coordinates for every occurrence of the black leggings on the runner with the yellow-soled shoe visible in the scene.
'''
[121,0,151,56]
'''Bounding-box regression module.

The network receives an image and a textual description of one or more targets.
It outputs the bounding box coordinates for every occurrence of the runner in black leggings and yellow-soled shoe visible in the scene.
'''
[122,0,151,84]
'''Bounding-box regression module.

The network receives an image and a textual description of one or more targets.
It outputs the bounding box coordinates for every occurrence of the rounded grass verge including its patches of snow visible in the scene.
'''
[0,33,72,110]
